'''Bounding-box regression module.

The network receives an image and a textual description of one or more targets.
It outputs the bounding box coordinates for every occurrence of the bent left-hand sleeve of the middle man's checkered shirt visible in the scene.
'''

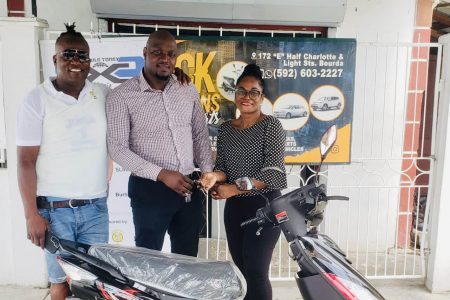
[106,86,162,181]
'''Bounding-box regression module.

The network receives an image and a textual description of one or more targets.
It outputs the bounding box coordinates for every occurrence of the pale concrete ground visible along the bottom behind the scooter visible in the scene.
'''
[0,280,450,300]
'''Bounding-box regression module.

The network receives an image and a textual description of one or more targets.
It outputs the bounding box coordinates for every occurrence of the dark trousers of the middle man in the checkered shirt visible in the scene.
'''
[128,176,203,256]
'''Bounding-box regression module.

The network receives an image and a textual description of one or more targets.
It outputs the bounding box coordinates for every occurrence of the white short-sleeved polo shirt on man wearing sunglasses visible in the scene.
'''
[16,78,110,199]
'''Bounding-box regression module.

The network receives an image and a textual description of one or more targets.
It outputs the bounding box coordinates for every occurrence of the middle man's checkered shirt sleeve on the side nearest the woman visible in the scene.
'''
[190,85,213,172]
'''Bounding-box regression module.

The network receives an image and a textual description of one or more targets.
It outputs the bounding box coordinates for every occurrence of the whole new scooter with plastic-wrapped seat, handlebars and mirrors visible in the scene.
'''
[45,126,384,300]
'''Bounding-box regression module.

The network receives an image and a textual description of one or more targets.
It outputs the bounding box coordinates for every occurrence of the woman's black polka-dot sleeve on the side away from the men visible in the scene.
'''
[254,118,287,190]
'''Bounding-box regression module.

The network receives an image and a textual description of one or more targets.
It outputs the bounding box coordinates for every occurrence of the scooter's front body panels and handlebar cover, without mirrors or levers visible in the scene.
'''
[266,184,384,300]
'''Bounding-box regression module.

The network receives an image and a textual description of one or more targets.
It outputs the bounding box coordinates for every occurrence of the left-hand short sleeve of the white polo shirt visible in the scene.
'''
[16,88,45,146]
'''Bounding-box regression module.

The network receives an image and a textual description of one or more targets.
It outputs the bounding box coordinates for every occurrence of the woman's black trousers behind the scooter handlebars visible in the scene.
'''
[224,191,281,300]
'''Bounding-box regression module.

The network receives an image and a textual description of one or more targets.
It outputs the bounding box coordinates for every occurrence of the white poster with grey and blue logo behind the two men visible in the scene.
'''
[40,37,170,251]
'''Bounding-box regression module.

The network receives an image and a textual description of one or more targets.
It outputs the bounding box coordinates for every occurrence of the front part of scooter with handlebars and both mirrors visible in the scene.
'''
[235,125,384,300]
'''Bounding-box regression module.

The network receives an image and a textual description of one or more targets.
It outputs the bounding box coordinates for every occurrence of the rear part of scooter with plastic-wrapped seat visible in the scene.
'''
[45,232,246,300]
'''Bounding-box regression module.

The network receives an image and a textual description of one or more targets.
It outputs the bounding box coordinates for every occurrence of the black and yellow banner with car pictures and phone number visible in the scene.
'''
[177,38,356,164]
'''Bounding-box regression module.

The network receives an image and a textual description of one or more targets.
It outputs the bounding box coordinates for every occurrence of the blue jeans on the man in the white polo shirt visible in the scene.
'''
[39,197,109,283]
